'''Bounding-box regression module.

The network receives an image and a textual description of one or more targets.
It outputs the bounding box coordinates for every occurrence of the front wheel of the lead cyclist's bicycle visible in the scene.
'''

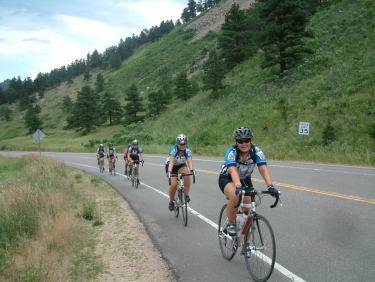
[244,215,276,282]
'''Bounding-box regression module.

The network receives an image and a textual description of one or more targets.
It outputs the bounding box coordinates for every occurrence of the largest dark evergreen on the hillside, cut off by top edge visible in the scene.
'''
[254,0,313,74]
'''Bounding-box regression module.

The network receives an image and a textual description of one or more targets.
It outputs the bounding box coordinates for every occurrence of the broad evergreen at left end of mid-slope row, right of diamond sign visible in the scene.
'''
[64,86,100,134]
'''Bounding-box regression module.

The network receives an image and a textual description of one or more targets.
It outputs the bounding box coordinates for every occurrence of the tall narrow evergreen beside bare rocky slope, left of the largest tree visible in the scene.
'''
[218,4,247,69]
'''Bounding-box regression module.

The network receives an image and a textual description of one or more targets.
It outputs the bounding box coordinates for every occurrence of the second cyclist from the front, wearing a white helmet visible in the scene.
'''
[165,134,195,211]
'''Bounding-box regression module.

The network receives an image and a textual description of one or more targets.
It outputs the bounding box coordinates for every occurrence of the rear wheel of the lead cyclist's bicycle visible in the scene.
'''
[218,204,237,260]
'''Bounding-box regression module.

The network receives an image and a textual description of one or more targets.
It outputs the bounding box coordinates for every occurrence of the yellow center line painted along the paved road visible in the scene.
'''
[147,163,375,205]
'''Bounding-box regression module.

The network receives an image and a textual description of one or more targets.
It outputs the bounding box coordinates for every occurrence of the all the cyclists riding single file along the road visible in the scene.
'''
[97,126,278,236]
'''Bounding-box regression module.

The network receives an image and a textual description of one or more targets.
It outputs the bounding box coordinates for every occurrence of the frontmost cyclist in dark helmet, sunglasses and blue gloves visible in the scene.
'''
[219,126,278,236]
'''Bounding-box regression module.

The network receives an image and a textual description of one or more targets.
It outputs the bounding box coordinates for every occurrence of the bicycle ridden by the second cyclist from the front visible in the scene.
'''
[169,172,195,226]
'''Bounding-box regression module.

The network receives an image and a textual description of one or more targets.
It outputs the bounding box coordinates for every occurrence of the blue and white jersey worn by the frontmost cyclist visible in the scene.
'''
[220,145,267,180]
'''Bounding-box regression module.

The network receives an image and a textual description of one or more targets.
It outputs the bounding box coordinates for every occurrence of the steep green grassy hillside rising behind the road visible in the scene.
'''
[0,0,375,166]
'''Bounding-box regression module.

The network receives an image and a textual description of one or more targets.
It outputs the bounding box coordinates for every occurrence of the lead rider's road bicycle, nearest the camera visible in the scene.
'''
[218,188,281,282]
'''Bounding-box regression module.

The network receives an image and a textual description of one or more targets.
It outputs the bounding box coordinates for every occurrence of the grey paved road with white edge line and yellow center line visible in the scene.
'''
[4,152,375,282]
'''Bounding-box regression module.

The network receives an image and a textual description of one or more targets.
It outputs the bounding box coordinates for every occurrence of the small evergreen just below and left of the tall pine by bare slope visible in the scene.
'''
[202,49,226,97]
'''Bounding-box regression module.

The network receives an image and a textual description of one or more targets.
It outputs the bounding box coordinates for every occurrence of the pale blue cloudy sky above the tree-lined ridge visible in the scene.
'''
[0,0,188,82]
